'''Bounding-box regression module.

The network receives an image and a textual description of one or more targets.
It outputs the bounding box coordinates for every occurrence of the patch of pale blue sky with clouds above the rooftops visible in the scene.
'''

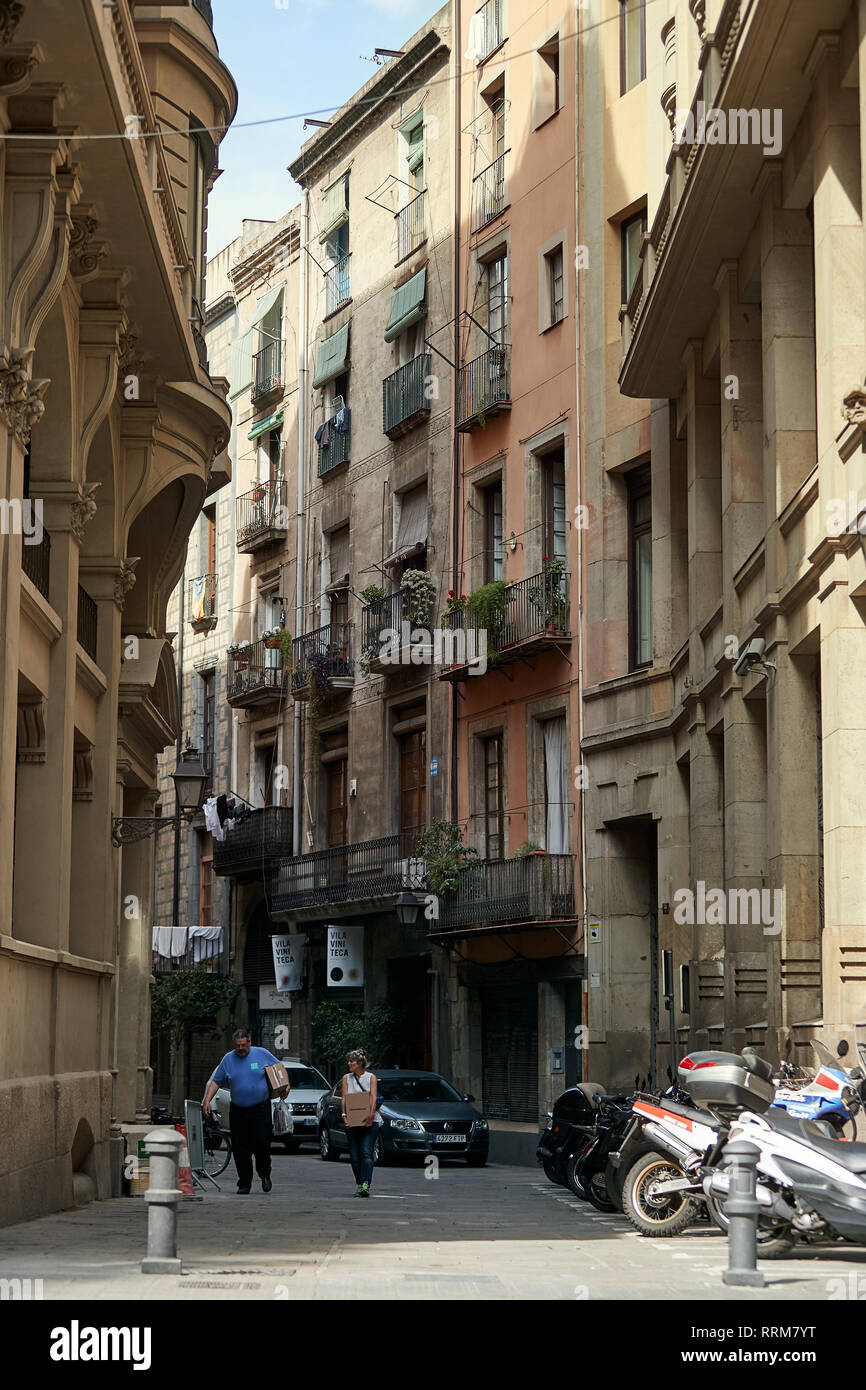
[207,0,439,256]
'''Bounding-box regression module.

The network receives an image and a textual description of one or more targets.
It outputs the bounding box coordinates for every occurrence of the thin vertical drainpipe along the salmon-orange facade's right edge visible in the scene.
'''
[574,4,589,1081]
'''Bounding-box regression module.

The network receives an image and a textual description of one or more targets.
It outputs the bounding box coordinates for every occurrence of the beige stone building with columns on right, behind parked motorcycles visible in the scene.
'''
[578,0,866,1084]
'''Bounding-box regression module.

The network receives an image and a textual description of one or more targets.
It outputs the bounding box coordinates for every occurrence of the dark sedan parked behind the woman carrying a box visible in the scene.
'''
[318,1070,489,1168]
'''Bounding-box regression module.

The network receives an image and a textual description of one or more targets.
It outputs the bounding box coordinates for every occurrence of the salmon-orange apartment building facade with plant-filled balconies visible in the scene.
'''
[434,0,584,1122]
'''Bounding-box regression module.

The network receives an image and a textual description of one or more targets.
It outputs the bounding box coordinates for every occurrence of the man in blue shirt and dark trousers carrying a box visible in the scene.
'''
[202,1029,289,1195]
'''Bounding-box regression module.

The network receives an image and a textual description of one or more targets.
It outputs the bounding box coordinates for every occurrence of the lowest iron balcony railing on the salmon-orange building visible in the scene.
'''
[430,855,575,935]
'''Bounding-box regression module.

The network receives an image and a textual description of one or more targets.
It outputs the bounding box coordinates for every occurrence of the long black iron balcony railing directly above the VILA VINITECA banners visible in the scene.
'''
[271,831,427,913]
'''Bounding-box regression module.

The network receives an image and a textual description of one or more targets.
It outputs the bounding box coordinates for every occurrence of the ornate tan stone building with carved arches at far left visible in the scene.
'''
[0,0,236,1223]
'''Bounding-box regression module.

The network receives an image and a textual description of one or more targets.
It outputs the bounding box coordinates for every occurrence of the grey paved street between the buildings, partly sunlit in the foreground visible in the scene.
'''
[0,1151,866,1302]
